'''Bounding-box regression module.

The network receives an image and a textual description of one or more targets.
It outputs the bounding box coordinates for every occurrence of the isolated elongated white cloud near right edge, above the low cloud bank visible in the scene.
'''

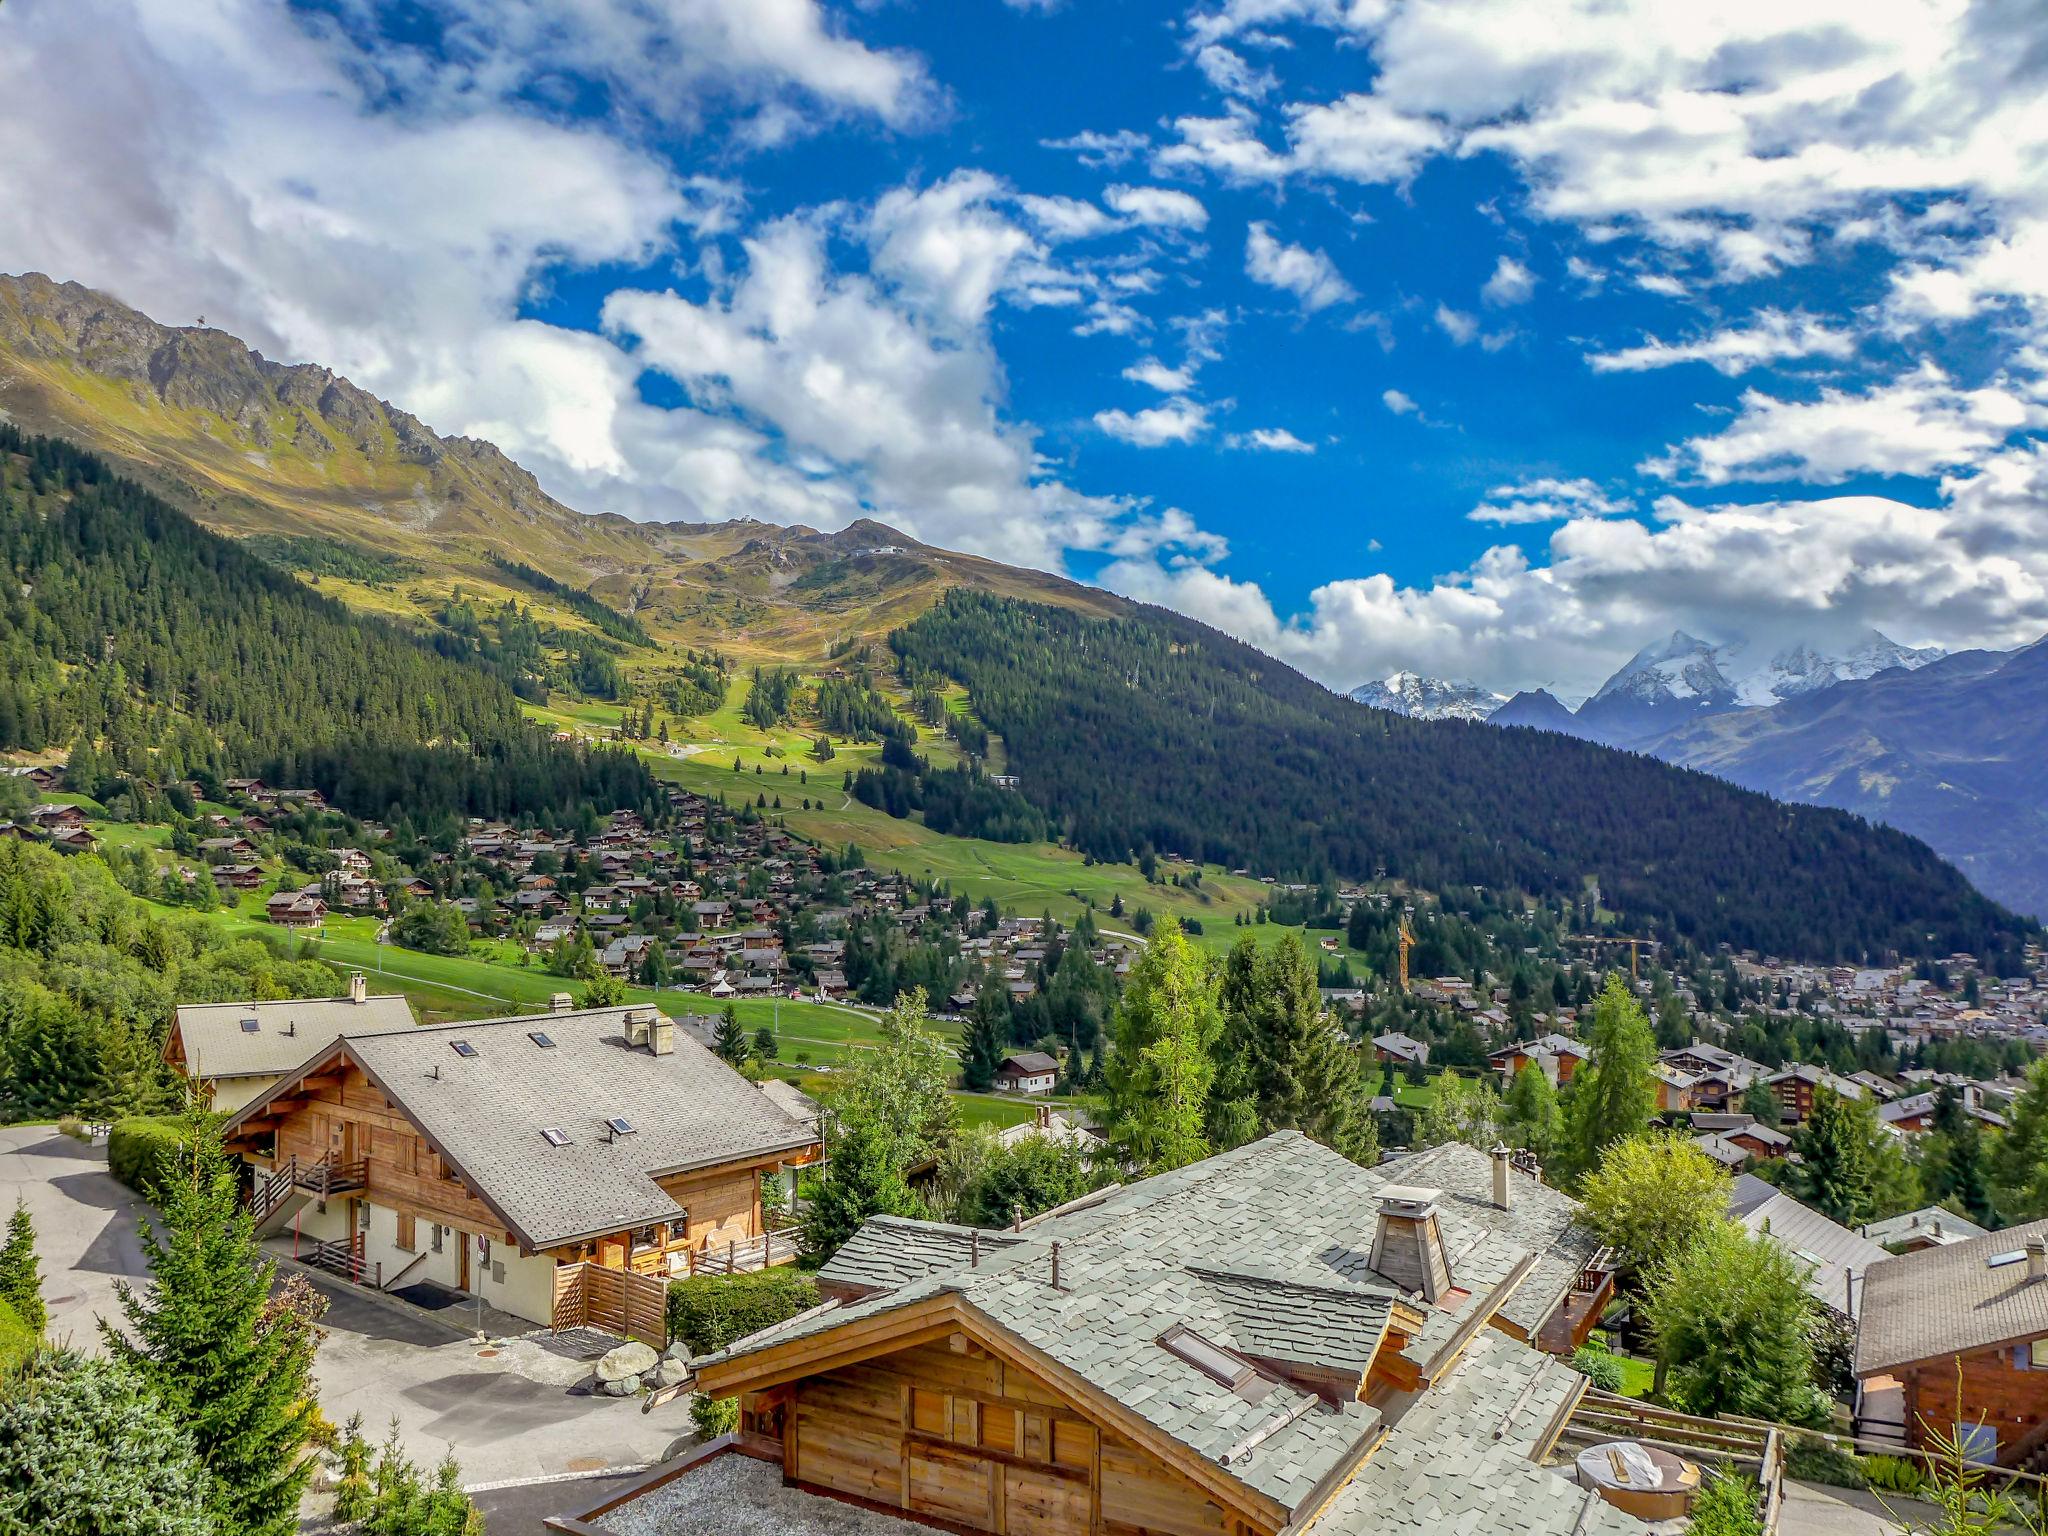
[1642,362,2048,485]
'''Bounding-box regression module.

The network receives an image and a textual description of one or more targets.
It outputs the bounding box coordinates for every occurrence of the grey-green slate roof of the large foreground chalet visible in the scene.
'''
[698,1133,1605,1536]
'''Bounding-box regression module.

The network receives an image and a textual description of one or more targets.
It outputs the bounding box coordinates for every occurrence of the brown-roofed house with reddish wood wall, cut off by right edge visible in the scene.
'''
[1855,1221,2048,1470]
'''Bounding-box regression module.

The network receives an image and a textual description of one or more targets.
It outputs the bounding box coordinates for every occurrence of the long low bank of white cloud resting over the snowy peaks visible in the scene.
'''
[1104,475,2048,696]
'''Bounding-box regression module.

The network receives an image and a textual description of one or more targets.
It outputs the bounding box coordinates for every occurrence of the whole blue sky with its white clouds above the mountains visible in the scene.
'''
[0,0,2048,694]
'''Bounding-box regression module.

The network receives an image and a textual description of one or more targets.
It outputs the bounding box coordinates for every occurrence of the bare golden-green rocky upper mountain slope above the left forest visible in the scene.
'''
[0,272,1116,659]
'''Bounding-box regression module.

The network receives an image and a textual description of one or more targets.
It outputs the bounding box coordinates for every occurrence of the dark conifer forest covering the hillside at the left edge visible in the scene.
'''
[0,426,655,819]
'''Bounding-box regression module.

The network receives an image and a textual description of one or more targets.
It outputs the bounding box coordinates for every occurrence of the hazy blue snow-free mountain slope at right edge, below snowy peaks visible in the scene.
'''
[1647,641,2048,918]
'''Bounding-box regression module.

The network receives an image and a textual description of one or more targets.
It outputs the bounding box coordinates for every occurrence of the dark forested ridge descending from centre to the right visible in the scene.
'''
[891,592,2028,958]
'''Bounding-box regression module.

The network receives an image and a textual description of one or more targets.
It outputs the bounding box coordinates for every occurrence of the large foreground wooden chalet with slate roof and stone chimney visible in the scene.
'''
[549,1133,1638,1536]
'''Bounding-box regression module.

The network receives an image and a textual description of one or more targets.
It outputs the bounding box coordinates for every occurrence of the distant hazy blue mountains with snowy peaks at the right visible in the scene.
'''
[1354,631,2048,918]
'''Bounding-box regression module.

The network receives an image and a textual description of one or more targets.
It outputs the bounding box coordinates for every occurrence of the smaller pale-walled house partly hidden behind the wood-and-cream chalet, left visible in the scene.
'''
[164,971,416,1114]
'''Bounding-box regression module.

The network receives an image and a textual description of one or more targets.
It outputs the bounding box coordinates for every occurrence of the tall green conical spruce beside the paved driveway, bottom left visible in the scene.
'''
[100,1118,326,1536]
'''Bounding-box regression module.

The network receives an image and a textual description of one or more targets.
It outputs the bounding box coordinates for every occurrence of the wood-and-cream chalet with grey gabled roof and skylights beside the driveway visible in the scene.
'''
[225,999,819,1325]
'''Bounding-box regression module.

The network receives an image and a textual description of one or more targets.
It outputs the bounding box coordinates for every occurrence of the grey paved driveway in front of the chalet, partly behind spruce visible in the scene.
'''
[0,1126,692,1536]
